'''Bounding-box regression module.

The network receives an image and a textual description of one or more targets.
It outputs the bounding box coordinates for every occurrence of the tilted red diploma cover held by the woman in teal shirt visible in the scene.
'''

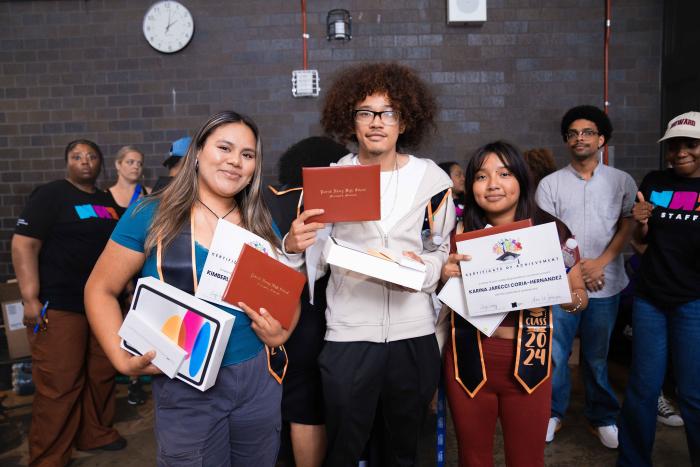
[221,245,306,329]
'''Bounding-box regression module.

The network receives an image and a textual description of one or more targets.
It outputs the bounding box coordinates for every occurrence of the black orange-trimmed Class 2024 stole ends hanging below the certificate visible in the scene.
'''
[452,307,552,398]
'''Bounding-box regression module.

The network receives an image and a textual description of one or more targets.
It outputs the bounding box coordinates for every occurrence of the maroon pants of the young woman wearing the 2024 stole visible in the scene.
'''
[445,337,552,467]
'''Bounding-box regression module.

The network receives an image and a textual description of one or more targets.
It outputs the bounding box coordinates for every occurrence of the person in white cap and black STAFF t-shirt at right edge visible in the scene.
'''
[617,112,700,467]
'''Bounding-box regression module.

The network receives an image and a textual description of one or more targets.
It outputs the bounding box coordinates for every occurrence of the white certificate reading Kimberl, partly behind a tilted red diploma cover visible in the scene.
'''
[194,219,274,308]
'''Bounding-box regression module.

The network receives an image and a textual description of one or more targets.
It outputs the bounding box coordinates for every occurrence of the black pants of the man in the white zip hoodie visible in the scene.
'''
[319,334,440,467]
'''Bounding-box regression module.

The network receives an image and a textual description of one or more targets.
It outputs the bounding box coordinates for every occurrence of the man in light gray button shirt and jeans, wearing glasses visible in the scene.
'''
[537,105,637,448]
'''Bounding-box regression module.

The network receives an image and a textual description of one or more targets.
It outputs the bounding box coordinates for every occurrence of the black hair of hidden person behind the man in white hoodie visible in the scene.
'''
[277,136,350,187]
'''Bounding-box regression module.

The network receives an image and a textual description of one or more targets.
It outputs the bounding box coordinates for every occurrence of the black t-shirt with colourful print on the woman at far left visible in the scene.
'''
[15,180,119,313]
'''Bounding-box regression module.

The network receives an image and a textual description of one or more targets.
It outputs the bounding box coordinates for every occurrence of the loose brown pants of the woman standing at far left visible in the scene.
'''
[27,309,119,467]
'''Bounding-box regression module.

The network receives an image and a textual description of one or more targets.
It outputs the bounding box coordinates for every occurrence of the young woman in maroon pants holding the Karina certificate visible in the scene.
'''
[441,141,588,466]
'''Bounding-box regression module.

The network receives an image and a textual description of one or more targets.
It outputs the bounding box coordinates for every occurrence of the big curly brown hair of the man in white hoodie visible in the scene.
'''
[321,63,437,149]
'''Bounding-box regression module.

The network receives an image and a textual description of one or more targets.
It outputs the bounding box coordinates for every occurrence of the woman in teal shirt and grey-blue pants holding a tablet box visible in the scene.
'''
[85,111,298,466]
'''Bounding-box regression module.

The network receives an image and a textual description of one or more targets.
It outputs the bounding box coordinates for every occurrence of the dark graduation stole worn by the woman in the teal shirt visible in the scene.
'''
[156,208,288,384]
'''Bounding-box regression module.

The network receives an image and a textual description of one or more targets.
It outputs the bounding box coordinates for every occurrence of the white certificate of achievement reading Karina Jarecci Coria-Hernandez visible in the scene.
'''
[457,222,571,316]
